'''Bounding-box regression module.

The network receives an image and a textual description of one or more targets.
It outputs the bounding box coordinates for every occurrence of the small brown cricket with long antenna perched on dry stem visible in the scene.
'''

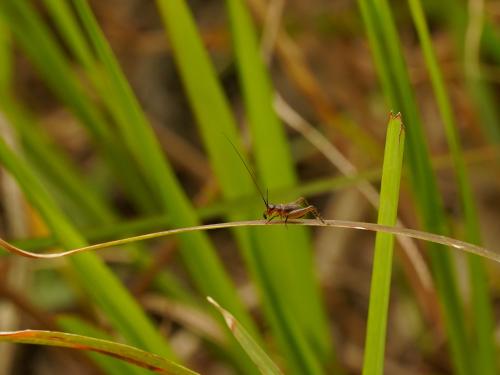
[224,134,325,224]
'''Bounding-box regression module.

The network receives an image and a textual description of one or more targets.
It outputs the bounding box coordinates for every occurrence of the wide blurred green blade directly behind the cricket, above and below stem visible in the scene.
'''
[226,0,334,365]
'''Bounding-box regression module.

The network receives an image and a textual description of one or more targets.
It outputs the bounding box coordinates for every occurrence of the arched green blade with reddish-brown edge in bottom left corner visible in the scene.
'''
[0,330,197,375]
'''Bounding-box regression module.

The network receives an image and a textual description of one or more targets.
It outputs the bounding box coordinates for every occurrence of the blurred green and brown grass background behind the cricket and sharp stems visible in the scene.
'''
[0,0,500,375]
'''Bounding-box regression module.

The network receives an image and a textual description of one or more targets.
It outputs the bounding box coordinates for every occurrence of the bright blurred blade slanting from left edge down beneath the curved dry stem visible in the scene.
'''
[0,135,173,357]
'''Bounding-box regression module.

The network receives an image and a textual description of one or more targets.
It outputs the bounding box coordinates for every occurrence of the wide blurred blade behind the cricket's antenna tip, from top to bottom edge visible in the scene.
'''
[158,1,328,373]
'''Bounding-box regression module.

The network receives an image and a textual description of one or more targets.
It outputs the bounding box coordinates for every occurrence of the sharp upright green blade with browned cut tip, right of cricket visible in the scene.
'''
[363,115,405,375]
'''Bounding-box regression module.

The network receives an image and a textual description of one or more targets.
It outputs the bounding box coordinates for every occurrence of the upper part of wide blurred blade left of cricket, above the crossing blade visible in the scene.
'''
[153,0,255,206]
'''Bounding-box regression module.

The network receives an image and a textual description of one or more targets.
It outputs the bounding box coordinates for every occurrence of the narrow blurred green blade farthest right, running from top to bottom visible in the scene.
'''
[409,0,496,375]
